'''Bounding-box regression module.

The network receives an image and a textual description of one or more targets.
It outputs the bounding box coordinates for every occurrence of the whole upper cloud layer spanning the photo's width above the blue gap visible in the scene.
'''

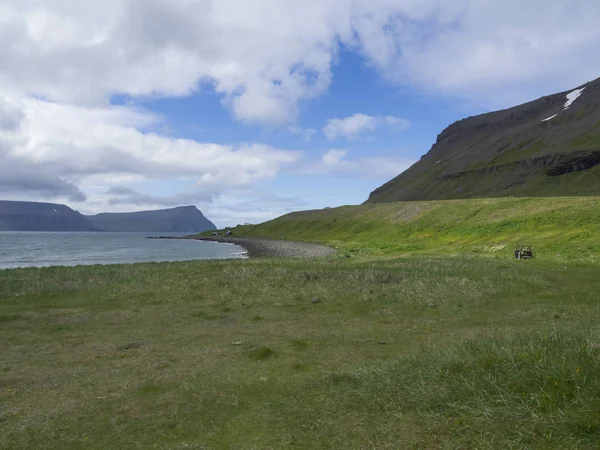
[0,0,600,123]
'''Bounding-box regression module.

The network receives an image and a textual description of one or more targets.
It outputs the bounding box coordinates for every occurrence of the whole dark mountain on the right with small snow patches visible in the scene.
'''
[366,79,600,203]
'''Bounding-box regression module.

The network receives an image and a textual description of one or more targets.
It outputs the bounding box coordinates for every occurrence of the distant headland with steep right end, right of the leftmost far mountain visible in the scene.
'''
[87,206,217,232]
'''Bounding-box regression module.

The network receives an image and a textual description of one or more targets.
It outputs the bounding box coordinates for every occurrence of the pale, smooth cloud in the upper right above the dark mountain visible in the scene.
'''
[386,0,600,104]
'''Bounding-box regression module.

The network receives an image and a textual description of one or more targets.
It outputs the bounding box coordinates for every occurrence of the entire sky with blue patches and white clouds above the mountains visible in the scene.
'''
[0,0,600,227]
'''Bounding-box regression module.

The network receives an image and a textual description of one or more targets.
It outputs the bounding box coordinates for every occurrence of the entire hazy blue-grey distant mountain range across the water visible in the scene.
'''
[0,200,216,233]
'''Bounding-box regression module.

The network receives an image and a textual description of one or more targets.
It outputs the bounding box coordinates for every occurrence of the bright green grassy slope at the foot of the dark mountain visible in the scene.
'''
[234,197,600,261]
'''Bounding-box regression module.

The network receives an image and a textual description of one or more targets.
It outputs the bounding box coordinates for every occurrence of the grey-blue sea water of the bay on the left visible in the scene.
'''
[0,231,246,269]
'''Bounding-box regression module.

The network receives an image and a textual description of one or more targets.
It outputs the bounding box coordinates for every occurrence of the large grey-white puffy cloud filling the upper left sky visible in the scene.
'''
[0,0,340,123]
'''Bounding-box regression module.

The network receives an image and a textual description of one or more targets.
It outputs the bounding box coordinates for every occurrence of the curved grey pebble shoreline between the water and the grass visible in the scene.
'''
[148,236,337,258]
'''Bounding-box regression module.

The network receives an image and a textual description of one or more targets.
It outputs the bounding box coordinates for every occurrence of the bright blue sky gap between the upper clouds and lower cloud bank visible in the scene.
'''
[142,51,468,163]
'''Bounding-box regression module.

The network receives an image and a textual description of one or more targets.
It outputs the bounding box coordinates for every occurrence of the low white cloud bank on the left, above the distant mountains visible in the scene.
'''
[0,94,299,207]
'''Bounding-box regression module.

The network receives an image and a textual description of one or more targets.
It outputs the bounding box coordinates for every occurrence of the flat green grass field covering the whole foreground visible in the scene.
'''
[0,255,600,449]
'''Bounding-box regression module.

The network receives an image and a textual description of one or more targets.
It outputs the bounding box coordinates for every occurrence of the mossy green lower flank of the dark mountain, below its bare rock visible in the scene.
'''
[370,120,600,202]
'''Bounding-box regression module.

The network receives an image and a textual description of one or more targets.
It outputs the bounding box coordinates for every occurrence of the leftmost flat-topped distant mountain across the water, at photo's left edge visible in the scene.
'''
[0,200,96,231]
